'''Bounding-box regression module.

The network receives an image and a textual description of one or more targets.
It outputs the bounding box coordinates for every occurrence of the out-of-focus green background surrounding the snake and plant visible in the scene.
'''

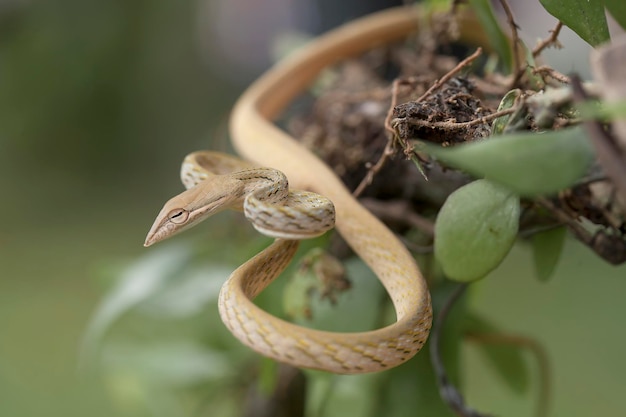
[0,0,626,417]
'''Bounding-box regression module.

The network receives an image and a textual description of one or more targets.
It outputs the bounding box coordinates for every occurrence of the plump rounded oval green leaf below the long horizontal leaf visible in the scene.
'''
[435,180,520,282]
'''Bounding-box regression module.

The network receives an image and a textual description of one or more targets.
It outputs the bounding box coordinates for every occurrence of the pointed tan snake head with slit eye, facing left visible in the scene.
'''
[143,177,242,247]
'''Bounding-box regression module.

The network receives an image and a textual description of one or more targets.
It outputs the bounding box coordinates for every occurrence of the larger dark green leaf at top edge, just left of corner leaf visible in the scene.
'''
[539,0,608,46]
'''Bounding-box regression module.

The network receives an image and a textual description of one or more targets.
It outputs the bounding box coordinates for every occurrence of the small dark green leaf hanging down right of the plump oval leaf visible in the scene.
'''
[530,227,566,281]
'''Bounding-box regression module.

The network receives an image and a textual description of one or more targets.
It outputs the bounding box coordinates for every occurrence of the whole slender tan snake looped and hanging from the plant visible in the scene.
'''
[144,6,476,374]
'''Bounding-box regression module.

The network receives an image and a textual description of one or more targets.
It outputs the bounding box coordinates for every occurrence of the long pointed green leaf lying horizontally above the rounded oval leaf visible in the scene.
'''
[417,127,594,197]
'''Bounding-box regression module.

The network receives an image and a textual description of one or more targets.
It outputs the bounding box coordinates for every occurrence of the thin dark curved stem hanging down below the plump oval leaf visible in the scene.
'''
[430,284,486,417]
